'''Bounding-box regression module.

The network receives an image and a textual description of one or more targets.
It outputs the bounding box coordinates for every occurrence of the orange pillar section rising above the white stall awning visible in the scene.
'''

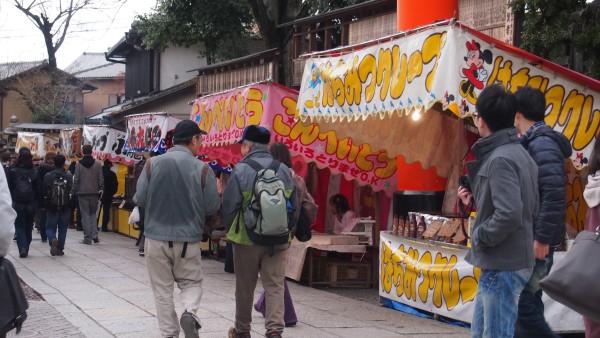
[397,0,458,32]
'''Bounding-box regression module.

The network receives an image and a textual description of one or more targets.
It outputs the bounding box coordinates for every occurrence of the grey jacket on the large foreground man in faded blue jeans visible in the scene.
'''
[466,128,539,270]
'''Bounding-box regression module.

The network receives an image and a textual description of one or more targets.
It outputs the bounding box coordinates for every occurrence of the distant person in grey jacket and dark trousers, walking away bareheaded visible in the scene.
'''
[73,144,104,245]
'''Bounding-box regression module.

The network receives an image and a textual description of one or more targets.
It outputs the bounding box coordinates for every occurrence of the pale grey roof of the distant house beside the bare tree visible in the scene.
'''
[65,52,125,79]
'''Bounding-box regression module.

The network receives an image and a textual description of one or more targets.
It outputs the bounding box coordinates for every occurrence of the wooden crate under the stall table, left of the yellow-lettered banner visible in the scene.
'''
[326,261,371,289]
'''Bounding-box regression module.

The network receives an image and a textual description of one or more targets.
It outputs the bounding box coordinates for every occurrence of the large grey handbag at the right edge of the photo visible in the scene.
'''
[540,226,600,322]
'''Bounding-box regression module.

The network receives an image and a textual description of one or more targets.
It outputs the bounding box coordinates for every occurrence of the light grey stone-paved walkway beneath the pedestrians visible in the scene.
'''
[9,230,469,338]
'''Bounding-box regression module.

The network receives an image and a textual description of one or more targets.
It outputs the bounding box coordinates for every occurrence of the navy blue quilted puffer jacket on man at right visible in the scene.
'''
[521,125,572,245]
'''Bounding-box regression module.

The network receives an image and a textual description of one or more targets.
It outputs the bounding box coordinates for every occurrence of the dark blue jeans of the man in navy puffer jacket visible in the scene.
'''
[515,247,558,338]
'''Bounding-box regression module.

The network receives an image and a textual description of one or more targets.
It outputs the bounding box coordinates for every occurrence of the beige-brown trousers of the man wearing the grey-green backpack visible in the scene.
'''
[233,243,289,334]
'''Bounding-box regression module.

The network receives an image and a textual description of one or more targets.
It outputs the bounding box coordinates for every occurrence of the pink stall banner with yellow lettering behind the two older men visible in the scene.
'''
[190,83,396,195]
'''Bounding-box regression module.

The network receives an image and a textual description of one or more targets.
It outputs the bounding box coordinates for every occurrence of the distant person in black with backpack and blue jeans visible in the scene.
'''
[43,154,73,256]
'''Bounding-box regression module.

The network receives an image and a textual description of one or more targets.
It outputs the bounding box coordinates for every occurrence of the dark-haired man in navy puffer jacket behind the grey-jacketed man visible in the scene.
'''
[515,87,572,338]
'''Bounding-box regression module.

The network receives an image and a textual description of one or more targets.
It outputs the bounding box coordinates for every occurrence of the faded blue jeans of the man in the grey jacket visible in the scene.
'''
[471,268,532,338]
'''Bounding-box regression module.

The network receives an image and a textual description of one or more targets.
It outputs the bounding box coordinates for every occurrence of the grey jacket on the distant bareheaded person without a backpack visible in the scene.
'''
[71,155,104,196]
